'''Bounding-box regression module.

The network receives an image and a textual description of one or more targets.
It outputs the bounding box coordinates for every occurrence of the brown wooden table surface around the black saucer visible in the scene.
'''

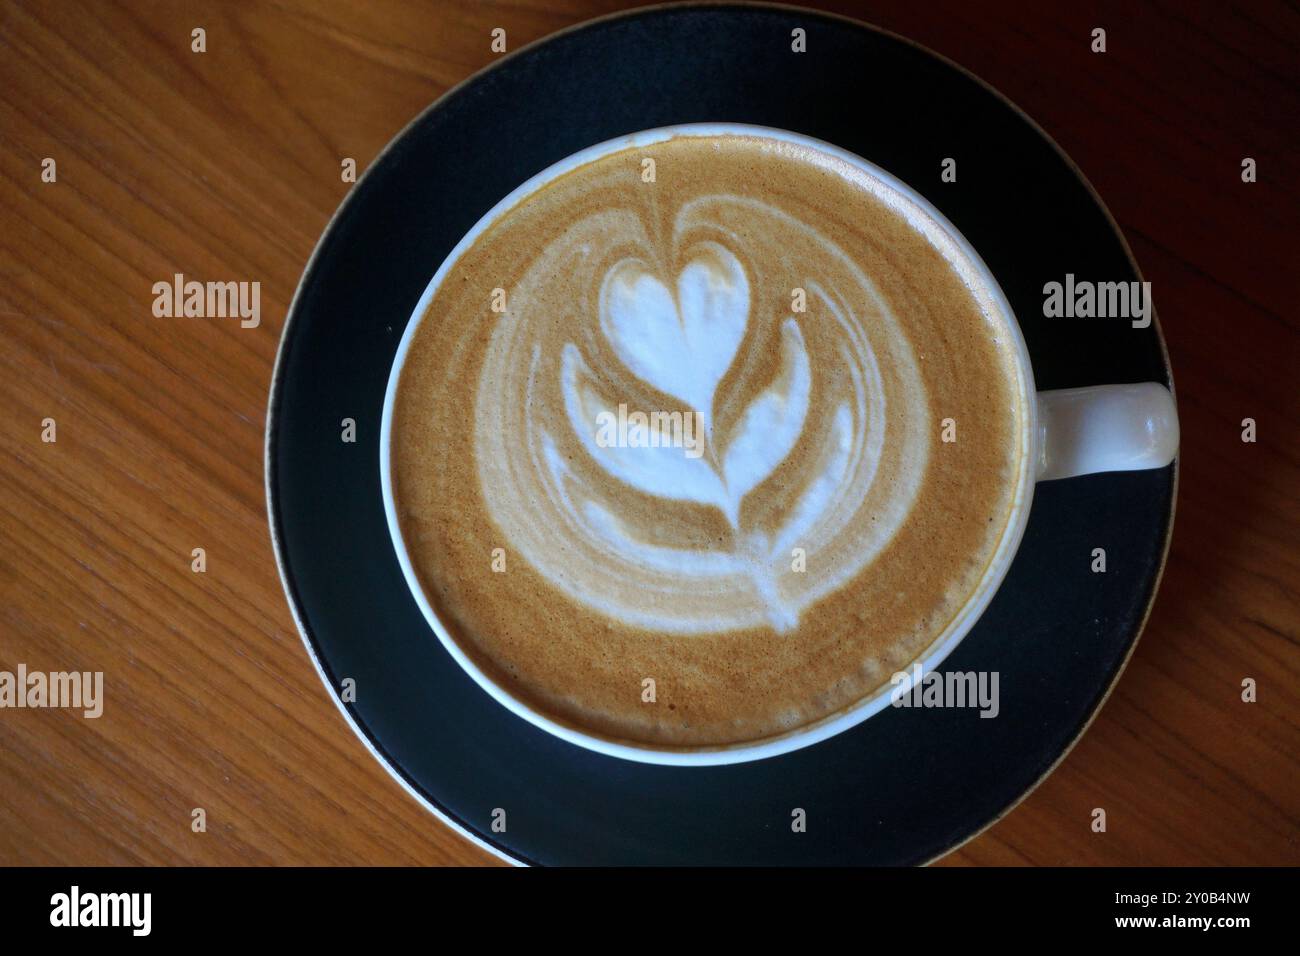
[0,0,1300,864]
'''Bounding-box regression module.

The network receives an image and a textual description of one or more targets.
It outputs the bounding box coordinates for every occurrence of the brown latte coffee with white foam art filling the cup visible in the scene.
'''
[391,135,1027,748]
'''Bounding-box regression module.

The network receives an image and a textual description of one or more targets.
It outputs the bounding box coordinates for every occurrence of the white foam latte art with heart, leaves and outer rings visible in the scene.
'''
[475,194,931,633]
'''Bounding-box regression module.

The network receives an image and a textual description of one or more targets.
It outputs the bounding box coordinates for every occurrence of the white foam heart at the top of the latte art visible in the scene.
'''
[601,242,749,433]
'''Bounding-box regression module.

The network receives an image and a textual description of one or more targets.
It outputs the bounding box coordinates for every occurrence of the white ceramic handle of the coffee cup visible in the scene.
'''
[1037,382,1178,481]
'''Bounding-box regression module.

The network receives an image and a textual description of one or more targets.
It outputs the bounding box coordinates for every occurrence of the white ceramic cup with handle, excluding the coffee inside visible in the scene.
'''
[380,124,1178,766]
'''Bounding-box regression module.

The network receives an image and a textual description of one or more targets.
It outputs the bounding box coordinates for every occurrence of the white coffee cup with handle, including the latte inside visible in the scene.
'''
[380,124,1178,766]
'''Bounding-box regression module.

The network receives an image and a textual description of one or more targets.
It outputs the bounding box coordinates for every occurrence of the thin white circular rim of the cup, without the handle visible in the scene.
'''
[380,122,1039,766]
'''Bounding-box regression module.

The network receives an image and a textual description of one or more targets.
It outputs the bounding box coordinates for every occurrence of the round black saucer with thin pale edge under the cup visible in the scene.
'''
[267,7,1175,864]
